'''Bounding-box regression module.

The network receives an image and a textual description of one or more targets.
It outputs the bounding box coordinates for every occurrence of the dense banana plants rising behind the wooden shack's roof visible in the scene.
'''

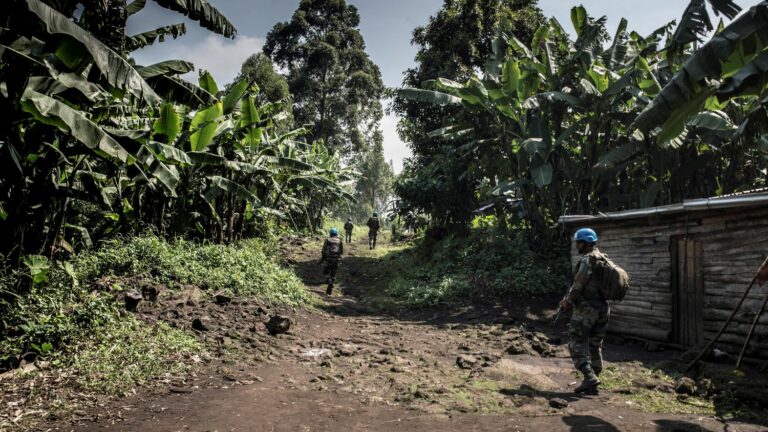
[398,0,768,238]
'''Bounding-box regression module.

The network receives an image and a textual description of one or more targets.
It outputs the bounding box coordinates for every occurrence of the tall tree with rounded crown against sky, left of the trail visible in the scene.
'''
[264,0,384,155]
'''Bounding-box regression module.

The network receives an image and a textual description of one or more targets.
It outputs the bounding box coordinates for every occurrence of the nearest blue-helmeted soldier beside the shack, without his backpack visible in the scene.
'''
[560,228,611,394]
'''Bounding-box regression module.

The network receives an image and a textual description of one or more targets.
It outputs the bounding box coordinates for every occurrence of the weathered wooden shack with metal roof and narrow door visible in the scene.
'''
[560,190,768,359]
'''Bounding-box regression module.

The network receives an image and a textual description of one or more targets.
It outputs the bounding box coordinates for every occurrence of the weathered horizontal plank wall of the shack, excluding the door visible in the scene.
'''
[570,207,768,359]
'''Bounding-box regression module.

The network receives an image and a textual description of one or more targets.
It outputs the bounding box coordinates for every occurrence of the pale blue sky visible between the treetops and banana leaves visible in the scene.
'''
[128,0,732,172]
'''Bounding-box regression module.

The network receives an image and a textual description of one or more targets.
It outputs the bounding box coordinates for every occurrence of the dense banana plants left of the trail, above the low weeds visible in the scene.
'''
[0,0,350,266]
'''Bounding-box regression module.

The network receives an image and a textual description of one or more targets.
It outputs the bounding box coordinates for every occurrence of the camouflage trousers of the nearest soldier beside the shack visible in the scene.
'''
[568,300,611,374]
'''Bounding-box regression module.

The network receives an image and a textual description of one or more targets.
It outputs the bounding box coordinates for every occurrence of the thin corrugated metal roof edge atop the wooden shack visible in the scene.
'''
[558,188,768,224]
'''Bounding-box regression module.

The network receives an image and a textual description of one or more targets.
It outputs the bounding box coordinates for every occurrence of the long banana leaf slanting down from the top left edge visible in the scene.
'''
[24,0,161,106]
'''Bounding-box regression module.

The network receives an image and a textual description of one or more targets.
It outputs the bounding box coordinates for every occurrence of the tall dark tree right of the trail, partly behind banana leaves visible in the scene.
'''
[391,0,544,230]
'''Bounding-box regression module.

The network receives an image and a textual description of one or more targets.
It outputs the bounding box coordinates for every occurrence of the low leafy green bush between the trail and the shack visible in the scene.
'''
[387,228,569,307]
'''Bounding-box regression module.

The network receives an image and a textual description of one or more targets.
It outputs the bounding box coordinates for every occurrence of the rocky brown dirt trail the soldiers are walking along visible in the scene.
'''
[41,239,766,432]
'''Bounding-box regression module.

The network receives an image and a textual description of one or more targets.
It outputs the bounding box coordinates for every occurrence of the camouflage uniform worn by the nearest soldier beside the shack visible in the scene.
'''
[566,248,611,375]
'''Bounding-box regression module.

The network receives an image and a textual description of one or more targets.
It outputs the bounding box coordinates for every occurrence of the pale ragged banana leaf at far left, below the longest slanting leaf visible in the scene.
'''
[21,88,134,163]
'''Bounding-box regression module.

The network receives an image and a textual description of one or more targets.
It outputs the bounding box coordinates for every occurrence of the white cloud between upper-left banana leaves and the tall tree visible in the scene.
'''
[177,34,264,87]
